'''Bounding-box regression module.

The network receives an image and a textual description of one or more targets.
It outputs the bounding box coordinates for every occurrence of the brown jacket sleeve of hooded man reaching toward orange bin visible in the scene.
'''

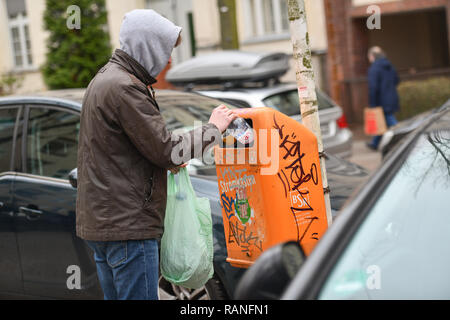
[116,85,220,168]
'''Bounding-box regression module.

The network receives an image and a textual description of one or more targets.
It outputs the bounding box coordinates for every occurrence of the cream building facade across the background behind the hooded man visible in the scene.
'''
[0,0,327,93]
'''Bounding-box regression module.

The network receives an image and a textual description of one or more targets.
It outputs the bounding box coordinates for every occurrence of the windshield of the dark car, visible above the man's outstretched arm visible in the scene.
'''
[157,93,235,132]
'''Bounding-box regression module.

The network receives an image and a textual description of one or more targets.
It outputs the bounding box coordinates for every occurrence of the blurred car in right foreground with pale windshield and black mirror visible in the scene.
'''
[239,103,450,300]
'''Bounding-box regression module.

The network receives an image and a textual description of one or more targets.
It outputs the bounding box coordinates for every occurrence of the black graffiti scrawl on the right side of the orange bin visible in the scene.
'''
[273,116,319,242]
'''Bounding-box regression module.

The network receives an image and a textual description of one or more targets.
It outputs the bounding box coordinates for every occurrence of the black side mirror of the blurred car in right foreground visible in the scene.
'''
[235,241,306,300]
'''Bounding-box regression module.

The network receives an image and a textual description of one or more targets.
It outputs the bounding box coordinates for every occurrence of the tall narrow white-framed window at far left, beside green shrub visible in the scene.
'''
[6,0,33,69]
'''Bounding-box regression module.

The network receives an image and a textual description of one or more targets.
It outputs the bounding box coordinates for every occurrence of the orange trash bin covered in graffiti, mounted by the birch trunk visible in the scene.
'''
[215,108,328,268]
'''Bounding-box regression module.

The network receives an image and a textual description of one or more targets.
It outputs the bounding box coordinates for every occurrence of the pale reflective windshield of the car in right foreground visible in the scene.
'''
[319,130,450,299]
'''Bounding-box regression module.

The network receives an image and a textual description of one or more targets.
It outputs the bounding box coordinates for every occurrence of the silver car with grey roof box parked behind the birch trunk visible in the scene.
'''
[166,51,353,157]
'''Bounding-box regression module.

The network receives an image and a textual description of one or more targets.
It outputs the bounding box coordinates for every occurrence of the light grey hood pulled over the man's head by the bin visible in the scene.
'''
[119,9,181,78]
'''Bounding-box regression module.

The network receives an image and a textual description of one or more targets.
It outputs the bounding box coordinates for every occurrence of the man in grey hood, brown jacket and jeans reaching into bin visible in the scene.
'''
[76,10,236,299]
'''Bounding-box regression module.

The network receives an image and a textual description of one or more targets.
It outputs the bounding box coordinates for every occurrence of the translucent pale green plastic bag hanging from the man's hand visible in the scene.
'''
[160,168,214,289]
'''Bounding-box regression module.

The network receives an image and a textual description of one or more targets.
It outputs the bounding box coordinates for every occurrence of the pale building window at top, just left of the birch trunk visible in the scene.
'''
[243,0,289,40]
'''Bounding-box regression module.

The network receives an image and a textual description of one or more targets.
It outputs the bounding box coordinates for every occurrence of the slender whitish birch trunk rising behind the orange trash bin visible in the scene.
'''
[286,0,332,225]
